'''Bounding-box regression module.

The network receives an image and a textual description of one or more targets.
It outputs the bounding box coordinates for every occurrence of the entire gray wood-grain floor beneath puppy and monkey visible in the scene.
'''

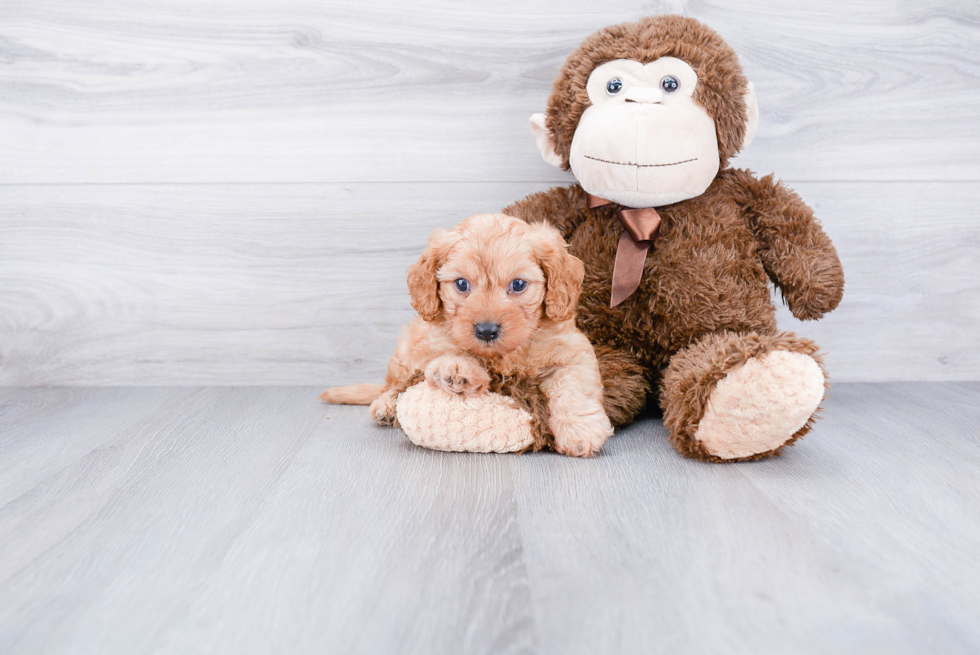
[0,383,980,655]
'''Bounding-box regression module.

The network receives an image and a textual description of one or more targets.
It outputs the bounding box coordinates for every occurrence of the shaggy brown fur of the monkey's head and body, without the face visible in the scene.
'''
[503,16,844,460]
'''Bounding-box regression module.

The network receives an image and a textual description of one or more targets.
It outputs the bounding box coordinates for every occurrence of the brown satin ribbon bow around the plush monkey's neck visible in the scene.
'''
[586,193,660,307]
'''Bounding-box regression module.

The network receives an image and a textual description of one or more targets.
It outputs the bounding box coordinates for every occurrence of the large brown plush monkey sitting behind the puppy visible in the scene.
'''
[390,16,844,461]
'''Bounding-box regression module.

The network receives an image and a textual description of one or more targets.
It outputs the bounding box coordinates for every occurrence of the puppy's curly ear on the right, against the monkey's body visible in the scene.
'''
[531,223,585,321]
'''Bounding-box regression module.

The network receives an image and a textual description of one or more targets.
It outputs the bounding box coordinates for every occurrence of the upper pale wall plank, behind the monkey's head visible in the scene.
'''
[0,0,980,184]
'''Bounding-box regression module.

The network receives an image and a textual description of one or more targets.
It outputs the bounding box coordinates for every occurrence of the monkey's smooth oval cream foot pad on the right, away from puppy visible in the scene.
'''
[694,350,825,459]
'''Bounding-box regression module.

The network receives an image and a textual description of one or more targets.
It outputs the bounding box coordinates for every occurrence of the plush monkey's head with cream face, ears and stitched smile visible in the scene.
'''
[531,16,759,207]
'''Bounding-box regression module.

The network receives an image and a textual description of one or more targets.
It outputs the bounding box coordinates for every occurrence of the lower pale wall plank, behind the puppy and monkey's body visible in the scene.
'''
[0,183,980,386]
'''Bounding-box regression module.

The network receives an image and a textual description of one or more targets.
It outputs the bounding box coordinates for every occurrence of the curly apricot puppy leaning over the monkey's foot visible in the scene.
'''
[320,214,612,457]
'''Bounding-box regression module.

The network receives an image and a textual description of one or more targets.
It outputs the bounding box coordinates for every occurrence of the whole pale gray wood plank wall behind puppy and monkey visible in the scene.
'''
[0,0,980,386]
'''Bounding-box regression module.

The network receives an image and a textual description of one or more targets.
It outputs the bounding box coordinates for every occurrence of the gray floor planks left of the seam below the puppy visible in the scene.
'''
[0,389,533,654]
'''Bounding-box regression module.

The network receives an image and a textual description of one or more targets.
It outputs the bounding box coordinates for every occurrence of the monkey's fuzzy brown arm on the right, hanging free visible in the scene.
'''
[732,170,844,320]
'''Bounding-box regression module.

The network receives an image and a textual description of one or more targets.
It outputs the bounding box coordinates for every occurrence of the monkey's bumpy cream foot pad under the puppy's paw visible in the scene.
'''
[396,382,534,453]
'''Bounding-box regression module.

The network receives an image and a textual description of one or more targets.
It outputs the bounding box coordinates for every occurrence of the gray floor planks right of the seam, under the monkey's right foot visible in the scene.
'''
[517,384,980,654]
